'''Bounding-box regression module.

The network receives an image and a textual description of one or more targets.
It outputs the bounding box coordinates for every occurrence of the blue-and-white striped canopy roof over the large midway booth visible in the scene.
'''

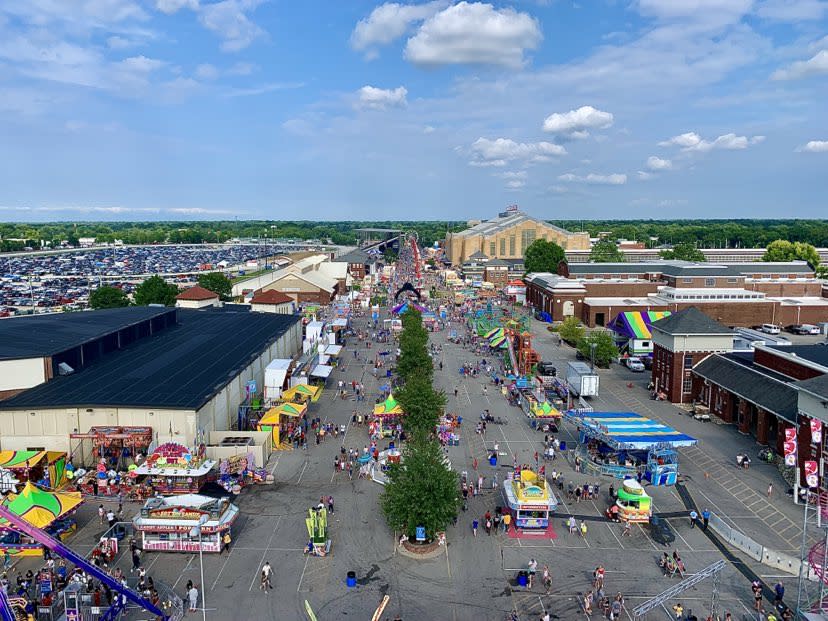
[567,412,698,450]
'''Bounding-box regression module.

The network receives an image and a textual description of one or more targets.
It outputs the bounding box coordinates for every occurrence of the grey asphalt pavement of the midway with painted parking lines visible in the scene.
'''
[12,308,816,621]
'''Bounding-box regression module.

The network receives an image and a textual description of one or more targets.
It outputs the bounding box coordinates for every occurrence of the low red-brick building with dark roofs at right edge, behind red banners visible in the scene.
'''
[691,345,828,484]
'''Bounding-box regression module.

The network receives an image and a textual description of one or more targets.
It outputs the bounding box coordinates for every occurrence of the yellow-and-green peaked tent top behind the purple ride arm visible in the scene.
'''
[0,483,83,556]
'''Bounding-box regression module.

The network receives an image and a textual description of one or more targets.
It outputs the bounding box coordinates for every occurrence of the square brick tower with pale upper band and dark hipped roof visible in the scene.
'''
[650,306,733,403]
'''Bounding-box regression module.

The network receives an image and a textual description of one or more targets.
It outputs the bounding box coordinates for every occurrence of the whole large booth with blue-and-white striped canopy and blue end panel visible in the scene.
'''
[565,410,698,485]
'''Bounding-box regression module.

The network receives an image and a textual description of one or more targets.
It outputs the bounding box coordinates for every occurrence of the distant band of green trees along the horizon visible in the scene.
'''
[0,220,828,252]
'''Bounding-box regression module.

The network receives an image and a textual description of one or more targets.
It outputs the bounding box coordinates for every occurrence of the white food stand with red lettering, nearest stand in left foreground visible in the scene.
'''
[132,494,239,552]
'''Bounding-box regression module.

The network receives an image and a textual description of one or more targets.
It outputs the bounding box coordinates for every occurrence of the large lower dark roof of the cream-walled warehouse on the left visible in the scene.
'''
[0,309,300,410]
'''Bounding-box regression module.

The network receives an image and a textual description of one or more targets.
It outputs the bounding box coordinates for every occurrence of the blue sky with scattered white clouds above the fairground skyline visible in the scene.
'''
[0,0,828,221]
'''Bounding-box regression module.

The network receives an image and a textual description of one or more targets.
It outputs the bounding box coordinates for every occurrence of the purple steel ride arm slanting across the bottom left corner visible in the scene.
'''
[0,506,170,621]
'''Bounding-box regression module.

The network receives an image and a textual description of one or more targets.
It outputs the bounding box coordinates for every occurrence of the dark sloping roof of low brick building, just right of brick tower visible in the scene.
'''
[693,354,797,423]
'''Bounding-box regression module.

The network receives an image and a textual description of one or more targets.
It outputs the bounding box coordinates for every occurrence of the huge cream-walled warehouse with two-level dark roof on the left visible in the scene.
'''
[0,307,302,451]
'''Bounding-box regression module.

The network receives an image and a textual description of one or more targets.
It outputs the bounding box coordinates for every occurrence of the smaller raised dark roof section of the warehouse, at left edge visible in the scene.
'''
[0,306,176,360]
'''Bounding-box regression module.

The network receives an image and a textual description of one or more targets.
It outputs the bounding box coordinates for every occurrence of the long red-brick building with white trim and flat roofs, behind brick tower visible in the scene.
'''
[526,261,828,327]
